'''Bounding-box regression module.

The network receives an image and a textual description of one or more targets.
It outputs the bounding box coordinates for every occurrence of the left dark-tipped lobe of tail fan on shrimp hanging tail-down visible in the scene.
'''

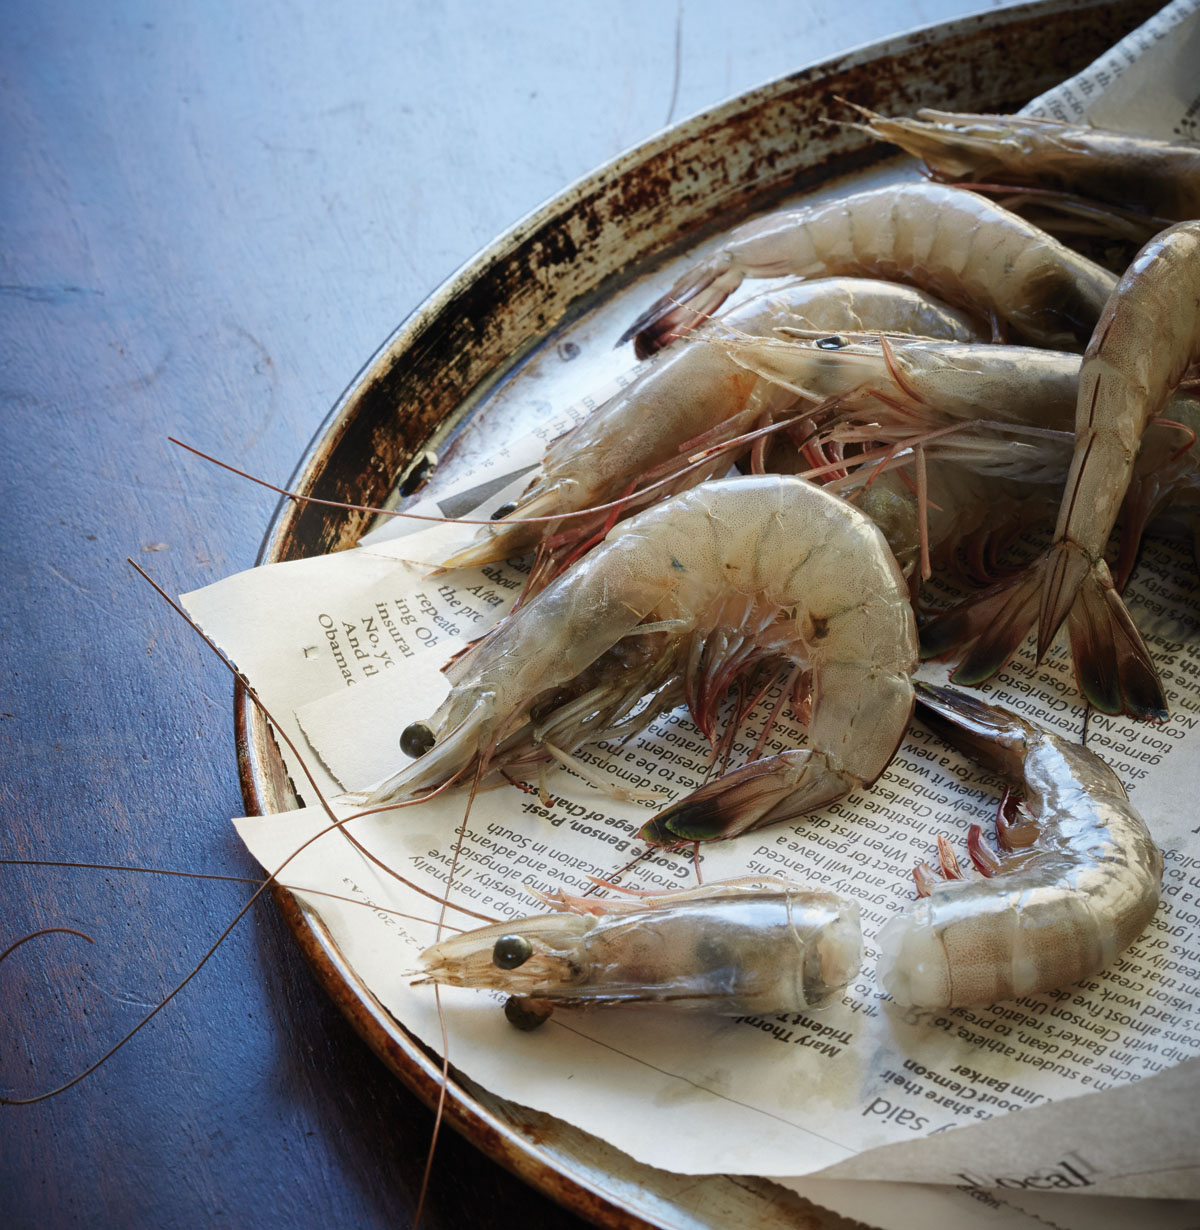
[921,562,1043,686]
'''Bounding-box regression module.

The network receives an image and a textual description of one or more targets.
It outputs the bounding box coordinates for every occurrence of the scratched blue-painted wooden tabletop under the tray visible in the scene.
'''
[0,0,1081,1226]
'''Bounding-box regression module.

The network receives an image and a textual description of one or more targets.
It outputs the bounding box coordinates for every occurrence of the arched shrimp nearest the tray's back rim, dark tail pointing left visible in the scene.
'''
[621,183,1115,354]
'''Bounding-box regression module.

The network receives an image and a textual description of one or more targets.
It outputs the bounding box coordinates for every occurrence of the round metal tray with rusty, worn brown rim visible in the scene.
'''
[236,0,1158,1228]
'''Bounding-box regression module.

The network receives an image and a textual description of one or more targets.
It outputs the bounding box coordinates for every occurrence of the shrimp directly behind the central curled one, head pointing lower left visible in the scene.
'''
[445,278,977,568]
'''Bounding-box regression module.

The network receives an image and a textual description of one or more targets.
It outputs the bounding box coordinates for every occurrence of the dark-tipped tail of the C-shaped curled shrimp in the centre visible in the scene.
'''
[641,748,862,846]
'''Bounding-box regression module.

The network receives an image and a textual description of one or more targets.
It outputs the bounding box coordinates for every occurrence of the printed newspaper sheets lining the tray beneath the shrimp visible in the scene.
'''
[186,2,1200,1226]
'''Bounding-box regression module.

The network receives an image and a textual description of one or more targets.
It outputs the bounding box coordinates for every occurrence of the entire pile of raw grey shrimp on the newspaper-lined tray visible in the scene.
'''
[395,112,1200,1023]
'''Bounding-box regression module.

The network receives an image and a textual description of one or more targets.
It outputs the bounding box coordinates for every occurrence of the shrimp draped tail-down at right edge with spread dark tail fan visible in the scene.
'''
[923,221,1200,721]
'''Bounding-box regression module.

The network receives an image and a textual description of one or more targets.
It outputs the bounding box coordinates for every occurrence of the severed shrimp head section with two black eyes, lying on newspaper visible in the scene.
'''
[418,879,862,1027]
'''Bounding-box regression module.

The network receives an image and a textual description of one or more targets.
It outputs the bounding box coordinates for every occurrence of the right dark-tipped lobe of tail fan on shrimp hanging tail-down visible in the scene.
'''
[1052,544,1169,722]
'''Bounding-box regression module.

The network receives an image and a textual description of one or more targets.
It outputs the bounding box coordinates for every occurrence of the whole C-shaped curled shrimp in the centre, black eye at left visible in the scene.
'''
[370,476,916,845]
